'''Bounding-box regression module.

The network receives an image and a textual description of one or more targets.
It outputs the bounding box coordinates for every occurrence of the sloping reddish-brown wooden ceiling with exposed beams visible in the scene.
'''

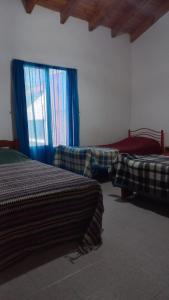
[24,0,169,42]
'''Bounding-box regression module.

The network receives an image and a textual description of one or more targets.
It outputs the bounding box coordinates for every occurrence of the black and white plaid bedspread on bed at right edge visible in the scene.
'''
[113,154,169,200]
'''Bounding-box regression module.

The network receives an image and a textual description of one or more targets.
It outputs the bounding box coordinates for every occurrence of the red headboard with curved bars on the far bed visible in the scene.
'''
[128,128,164,152]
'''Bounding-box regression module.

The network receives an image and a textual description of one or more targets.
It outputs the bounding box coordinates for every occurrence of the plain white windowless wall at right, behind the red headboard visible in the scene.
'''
[130,13,169,144]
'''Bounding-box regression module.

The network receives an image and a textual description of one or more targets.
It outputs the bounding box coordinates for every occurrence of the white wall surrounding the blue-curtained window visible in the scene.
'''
[0,0,131,145]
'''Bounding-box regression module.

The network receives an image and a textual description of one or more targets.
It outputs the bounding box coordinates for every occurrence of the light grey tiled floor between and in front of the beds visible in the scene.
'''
[0,183,169,300]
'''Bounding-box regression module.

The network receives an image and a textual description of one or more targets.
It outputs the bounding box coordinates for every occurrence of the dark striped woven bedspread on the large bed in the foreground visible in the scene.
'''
[0,160,103,269]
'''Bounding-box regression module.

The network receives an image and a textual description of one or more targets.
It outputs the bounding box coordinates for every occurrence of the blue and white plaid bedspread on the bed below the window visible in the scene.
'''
[54,146,118,177]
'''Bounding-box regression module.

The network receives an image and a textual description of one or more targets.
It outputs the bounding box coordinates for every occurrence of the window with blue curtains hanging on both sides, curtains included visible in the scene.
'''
[12,60,79,164]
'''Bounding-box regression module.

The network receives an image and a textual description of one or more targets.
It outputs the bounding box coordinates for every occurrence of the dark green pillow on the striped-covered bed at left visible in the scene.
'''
[0,148,28,164]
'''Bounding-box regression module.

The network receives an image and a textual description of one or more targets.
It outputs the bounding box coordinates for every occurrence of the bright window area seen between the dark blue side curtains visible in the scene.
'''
[24,65,68,146]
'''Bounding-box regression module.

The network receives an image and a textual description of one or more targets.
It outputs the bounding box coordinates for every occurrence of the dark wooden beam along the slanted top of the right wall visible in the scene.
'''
[130,1,169,42]
